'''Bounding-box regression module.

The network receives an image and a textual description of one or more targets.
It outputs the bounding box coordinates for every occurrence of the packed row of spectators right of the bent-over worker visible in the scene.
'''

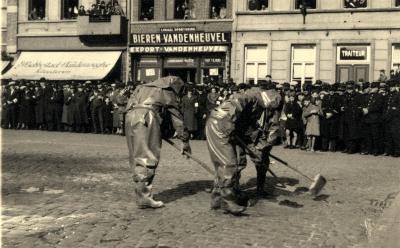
[281,80,400,156]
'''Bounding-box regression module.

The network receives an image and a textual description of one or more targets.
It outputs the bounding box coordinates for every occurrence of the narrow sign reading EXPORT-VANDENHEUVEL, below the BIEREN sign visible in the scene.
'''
[130,46,228,53]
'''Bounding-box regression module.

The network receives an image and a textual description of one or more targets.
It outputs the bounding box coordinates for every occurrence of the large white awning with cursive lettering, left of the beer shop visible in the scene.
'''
[3,51,121,80]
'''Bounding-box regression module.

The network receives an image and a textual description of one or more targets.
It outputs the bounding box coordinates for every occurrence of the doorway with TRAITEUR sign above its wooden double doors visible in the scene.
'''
[336,45,371,82]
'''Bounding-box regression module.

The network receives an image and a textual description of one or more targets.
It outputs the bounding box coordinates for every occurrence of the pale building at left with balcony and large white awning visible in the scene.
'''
[6,0,127,80]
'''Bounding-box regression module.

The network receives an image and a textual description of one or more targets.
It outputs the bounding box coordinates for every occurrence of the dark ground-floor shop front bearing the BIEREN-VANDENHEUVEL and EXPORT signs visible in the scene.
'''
[130,29,231,84]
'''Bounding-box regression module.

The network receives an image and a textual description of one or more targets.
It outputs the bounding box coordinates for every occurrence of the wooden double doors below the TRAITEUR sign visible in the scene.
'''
[336,65,369,82]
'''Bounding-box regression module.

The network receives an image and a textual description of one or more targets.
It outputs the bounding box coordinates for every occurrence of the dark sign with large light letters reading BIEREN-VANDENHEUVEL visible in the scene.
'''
[132,32,231,45]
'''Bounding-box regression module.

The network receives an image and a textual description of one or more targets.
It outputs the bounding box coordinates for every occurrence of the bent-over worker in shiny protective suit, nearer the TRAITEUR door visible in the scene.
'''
[206,83,281,215]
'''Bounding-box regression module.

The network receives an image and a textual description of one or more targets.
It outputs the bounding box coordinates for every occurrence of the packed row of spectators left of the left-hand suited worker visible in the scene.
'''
[2,80,132,134]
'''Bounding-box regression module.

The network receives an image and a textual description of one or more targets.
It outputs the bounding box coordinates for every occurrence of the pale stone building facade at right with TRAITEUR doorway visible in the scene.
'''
[231,0,400,83]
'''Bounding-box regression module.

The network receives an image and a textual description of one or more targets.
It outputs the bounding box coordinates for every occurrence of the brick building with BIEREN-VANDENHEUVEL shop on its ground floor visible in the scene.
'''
[129,0,233,84]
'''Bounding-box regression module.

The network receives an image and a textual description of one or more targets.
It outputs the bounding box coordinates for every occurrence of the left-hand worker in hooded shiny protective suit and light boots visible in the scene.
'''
[125,76,190,208]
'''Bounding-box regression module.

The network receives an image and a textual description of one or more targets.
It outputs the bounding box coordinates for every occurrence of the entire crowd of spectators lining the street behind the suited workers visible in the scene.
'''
[2,72,400,157]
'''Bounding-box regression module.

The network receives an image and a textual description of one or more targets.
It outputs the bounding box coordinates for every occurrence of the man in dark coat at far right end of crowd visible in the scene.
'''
[383,80,400,157]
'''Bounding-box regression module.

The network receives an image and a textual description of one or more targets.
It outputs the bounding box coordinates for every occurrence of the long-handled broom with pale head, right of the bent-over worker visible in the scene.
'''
[235,136,326,195]
